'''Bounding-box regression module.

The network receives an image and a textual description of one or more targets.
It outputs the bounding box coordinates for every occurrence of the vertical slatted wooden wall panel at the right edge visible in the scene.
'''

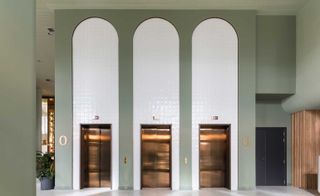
[292,110,320,189]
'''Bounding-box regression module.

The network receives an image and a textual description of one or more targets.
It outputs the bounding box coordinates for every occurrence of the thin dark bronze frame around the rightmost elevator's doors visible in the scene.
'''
[198,124,231,189]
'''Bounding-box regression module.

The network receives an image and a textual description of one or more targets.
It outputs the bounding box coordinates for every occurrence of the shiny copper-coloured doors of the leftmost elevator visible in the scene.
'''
[80,125,111,188]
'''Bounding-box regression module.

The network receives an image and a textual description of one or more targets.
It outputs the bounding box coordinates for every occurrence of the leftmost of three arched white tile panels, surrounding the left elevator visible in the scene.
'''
[73,18,119,189]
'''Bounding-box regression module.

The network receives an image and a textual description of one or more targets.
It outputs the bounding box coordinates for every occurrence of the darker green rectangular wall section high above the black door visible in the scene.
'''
[256,16,296,94]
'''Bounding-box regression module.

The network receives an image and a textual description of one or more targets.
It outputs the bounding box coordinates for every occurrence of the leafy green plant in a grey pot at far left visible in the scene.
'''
[36,151,54,190]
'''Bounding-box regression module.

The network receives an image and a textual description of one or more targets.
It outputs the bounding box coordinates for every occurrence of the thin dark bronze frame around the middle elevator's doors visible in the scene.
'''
[139,124,172,190]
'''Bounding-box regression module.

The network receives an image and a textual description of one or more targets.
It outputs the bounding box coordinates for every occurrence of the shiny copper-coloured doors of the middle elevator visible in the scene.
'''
[141,125,171,188]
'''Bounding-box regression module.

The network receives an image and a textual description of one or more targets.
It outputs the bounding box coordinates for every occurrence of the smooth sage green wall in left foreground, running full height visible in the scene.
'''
[0,0,36,196]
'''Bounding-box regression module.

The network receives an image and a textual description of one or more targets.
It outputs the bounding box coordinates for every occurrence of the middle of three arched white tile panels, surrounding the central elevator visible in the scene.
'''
[133,18,179,189]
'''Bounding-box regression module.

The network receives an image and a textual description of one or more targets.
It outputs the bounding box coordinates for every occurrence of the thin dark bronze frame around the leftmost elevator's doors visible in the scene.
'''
[79,124,113,189]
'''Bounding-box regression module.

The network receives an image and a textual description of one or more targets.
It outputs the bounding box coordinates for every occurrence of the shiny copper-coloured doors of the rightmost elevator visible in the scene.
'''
[199,125,230,188]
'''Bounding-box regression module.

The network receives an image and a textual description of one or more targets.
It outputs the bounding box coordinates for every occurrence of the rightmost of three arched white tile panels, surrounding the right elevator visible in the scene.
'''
[192,18,238,190]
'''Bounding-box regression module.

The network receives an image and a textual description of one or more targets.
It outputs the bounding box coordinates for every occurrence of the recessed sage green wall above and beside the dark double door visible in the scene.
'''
[256,101,291,185]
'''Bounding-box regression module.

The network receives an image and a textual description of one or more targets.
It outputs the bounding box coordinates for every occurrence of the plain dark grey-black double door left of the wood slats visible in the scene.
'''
[256,127,287,186]
